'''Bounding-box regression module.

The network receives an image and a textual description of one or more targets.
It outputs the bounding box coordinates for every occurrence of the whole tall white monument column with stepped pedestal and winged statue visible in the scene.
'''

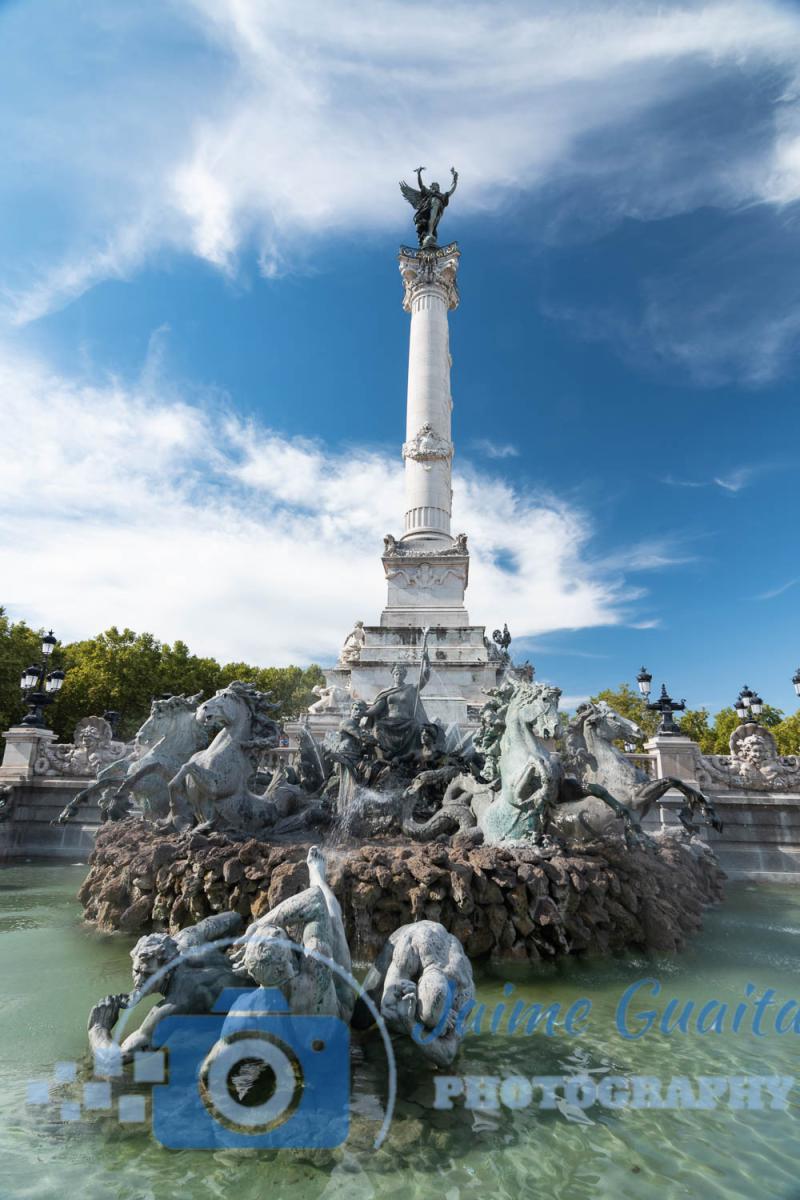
[309,167,505,730]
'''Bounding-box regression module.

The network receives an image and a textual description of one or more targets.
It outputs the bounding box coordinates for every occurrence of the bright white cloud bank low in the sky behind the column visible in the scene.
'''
[0,337,690,664]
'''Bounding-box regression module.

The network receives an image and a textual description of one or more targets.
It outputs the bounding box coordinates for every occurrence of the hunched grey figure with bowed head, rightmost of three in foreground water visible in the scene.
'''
[363,920,475,1067]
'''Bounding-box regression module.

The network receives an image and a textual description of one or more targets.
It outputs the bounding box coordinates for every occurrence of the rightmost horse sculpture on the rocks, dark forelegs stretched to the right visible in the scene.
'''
[552,701,722,840]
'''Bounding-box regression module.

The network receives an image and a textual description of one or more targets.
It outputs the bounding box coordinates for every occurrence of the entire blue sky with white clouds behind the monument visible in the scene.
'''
[0,0,800,709]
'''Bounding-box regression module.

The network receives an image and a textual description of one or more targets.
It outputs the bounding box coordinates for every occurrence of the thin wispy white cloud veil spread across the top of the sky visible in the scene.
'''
[0,0,800,338]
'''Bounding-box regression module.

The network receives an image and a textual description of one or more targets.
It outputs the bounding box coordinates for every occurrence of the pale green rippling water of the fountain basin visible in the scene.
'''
[0,864,800,1200]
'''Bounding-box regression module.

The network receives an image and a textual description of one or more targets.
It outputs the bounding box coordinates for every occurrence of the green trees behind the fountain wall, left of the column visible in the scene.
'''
[0,608,324,740]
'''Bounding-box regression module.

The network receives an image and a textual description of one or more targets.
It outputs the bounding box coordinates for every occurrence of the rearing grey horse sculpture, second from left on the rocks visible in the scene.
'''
[169,682,288,833]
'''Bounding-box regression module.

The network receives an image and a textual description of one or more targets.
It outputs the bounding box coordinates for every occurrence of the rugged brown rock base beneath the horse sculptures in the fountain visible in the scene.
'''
[79,818,724,962]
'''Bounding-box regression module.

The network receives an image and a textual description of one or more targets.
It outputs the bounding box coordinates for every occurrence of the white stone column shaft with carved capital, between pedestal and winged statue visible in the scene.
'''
[399,242,461,550]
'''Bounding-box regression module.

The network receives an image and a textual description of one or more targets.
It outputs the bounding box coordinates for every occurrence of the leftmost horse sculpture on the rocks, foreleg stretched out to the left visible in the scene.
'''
[58,692,207,823]
